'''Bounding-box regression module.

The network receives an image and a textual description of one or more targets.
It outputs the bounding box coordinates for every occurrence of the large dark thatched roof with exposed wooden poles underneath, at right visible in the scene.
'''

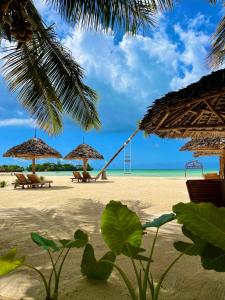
[140,69,225,138]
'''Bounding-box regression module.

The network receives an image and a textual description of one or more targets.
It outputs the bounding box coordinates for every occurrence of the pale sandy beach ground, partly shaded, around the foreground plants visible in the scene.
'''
[0,176,225,300]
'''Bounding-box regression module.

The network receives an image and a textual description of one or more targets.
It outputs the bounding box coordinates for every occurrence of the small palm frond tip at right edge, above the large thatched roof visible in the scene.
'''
[209,17,225,68]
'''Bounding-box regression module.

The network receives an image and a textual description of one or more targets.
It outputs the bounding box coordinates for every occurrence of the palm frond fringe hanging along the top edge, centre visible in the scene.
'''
[47,0,173,34]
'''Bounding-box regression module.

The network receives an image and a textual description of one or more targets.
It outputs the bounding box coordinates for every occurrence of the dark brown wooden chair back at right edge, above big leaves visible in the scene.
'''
[186,179,225,207]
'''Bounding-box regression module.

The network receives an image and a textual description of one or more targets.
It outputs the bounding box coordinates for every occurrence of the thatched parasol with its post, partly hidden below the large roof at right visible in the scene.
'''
[180,137,225,178]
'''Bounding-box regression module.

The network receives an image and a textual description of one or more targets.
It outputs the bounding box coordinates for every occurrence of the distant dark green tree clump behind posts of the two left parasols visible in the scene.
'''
[27,162,93,172]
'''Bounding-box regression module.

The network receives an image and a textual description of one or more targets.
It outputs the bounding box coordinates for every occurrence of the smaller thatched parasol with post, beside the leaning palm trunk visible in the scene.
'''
[64,144,104,171]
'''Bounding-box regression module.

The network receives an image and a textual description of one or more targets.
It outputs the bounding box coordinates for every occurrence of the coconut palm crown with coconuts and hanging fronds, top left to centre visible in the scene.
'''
[0,0,172,134]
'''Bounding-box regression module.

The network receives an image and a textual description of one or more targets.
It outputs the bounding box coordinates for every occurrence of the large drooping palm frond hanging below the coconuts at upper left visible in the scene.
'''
[0,2,100,134]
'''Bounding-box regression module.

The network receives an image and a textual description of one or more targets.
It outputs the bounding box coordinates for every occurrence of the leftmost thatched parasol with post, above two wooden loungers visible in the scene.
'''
[3,138,62,173]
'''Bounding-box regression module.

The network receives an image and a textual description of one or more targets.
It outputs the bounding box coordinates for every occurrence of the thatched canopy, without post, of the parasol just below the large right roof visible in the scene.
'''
[180,137,225,152]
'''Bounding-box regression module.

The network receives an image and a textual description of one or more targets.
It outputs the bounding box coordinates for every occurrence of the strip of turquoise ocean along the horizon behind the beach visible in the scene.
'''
[34,169,218,177]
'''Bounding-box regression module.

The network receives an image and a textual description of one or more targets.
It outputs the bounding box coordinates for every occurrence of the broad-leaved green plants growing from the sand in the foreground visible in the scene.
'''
[0,201,225,300]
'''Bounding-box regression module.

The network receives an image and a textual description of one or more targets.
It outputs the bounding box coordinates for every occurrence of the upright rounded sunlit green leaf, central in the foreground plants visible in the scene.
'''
[101,200,143,255]
